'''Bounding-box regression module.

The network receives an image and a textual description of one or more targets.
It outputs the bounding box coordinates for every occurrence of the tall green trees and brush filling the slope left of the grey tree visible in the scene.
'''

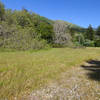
[0,3,53,50]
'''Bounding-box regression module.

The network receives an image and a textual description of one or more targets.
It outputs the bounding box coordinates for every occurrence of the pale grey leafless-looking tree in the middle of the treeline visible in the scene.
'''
[53,21,71,45]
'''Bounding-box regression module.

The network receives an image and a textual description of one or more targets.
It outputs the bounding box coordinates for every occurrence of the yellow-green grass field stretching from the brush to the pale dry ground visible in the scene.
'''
[0,48,100,100]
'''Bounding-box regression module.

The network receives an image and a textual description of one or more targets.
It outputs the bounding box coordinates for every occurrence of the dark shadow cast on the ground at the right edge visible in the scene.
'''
[81,60,100,81]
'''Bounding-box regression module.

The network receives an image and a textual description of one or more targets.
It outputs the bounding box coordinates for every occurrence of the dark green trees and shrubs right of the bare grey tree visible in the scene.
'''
[74,25,100,47]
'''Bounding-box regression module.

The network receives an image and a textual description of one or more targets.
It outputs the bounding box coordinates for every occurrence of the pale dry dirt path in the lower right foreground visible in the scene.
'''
[27,60,100,100]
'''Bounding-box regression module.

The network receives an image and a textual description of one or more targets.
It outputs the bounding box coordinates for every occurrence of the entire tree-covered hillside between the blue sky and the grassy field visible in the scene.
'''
[0,2,100,50]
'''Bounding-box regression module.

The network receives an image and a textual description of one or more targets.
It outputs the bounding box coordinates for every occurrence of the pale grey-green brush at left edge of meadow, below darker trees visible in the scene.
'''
[0,23,49,50]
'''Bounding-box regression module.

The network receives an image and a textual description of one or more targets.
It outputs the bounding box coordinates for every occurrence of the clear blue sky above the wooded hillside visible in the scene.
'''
[1,0,100,27]
